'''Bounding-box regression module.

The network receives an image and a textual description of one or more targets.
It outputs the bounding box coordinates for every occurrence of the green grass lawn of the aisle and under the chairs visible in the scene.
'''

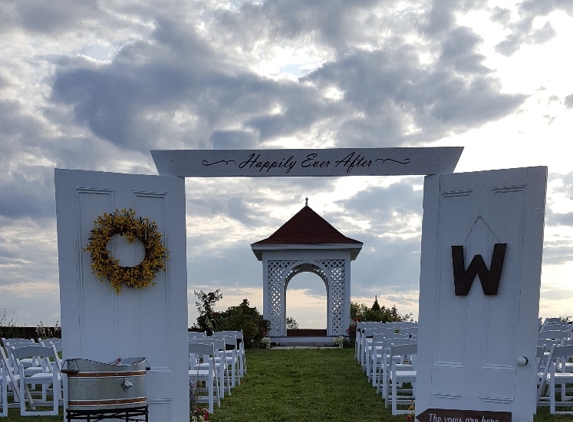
[0,349,573,422]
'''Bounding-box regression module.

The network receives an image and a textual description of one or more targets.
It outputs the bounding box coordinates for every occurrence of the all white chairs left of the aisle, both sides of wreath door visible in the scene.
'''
[0,331,247,417]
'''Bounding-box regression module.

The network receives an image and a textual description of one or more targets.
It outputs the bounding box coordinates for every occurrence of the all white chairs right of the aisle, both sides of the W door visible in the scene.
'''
[355,319,573,415]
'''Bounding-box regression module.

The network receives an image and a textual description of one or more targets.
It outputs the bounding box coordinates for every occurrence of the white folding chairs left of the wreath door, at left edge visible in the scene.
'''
[0,338,63,416]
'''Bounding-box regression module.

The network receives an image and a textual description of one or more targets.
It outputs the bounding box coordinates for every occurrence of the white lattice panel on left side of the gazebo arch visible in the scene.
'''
[266,260,299,336]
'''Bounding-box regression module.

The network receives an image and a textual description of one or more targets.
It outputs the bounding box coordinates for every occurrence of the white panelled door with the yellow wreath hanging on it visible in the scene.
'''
[55,169,189,422]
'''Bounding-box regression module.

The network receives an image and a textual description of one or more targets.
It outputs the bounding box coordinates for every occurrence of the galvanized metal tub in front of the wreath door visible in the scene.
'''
[62,357,149,411]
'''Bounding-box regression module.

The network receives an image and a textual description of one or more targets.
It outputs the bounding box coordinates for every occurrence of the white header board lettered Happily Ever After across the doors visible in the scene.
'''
[151,147,463,177]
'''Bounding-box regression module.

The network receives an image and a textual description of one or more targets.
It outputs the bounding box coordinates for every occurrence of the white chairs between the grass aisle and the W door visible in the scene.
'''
[355,321,418,415]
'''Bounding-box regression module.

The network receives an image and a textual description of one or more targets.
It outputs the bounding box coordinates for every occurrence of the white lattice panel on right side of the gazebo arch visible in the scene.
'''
[316,259,348,335]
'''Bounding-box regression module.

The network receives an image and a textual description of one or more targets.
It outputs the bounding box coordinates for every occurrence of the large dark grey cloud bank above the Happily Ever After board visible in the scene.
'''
[45,1,525,157]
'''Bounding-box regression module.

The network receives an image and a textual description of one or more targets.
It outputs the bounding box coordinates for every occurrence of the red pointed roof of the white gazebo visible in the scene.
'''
[251,205,362,248]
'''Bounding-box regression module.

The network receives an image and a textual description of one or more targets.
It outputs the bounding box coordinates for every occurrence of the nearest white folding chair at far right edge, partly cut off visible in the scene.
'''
[537,344,573,415]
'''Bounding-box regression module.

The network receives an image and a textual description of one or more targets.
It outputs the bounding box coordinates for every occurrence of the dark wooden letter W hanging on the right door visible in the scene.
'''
[452,243,507,296]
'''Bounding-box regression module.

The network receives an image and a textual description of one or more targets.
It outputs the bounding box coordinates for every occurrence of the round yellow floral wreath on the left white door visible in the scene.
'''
[84,208,167,293]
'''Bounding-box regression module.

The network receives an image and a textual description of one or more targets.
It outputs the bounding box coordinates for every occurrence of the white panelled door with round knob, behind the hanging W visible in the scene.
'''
[416,167,547,422]
